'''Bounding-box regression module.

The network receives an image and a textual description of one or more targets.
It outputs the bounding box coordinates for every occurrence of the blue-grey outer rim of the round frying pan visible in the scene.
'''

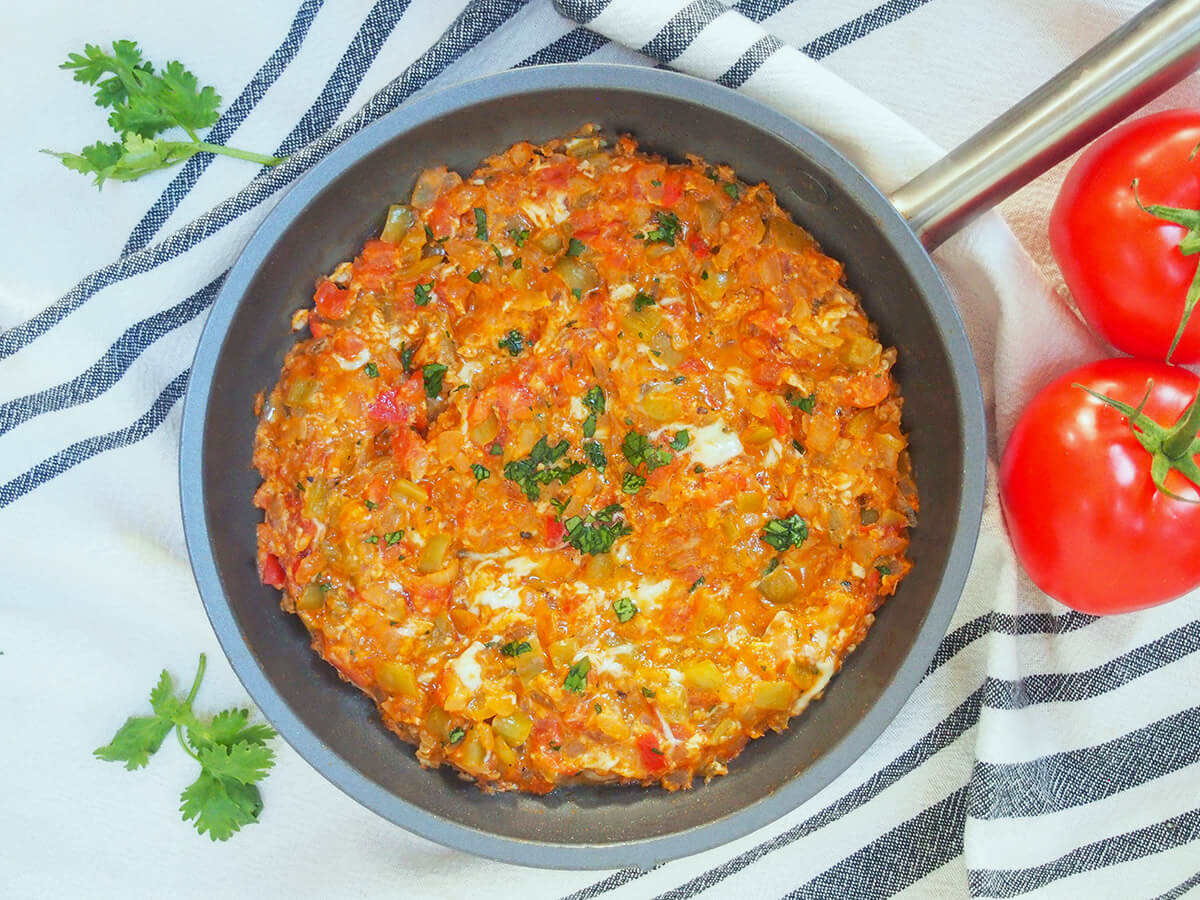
[179,64,986,869]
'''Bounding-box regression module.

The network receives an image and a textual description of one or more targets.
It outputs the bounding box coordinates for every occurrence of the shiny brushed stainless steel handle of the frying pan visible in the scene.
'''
[890,0,1200,250]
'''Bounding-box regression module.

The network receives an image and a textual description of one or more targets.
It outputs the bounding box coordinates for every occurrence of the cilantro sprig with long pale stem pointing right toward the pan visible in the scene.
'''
[42,41,287,187]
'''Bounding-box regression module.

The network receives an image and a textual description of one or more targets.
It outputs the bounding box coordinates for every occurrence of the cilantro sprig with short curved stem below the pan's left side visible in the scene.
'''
[94,653,276,841]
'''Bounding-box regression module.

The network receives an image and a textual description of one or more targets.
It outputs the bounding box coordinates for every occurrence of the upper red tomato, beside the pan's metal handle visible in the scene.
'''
[1050,109,1200,362]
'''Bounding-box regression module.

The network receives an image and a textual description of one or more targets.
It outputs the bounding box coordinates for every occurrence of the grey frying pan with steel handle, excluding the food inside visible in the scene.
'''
[180,0,1200,869]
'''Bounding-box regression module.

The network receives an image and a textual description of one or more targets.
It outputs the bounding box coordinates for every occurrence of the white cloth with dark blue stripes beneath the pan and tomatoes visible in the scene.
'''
[0,0,1200,900]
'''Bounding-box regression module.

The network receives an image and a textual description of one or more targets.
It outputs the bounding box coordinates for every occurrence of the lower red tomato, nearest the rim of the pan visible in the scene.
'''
[1000,359,1200,613]
